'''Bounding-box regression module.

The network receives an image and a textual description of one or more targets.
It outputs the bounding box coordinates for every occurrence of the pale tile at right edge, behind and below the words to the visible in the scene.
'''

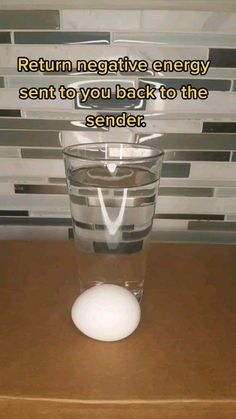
[146,92,236,116]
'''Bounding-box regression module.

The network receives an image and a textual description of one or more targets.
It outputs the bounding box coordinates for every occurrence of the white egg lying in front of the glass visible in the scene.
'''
[71,284,141,342]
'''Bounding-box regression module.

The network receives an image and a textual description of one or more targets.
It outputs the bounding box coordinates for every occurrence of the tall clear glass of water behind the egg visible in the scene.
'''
[63,142,163,300]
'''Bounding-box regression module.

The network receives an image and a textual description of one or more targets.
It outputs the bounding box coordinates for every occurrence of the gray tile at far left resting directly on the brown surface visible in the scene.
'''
[0,225,68,240]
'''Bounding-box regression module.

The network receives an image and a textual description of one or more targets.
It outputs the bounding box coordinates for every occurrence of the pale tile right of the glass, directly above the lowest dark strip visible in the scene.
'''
[156,196,236,214]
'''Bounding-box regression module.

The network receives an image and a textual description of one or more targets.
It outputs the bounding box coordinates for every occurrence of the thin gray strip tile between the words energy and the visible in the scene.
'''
[139,78,231,91]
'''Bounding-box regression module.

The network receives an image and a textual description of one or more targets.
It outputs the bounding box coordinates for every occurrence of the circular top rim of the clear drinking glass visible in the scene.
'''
[62,141,164,162]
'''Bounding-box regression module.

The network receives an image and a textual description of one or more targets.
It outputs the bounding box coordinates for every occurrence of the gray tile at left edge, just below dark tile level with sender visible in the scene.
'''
[0,131,60,147]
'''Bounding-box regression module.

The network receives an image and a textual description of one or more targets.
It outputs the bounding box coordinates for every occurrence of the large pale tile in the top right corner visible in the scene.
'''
[141,10,236,33]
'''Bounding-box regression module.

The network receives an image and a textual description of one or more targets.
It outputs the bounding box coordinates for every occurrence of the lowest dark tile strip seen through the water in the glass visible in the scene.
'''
[93,240,143,254]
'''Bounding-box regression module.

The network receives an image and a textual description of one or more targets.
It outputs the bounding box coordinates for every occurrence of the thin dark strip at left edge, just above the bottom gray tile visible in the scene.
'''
[0,220,71,227]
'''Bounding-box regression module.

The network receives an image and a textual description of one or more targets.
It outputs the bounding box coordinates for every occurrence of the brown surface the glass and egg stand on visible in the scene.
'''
[0,242,236,419]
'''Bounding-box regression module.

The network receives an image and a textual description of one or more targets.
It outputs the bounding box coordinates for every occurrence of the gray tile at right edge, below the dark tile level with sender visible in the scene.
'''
[137,133,236,151]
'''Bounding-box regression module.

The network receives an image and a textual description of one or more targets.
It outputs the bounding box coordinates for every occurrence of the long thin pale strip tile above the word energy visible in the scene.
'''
[113,32,236,47]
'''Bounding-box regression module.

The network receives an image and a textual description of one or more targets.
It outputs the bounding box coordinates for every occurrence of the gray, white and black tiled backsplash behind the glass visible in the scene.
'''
[0,6,236,243]
